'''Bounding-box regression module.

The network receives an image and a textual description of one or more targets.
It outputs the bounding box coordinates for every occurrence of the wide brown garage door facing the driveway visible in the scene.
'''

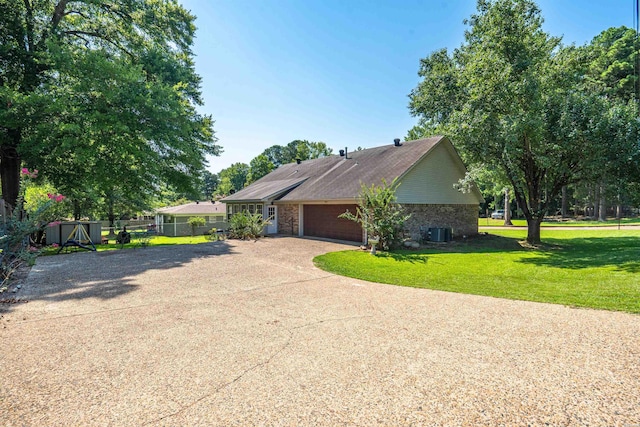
[304,205,362,242]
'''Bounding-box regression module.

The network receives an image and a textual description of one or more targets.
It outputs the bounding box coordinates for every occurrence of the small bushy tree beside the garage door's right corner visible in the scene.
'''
[338,178,411,250]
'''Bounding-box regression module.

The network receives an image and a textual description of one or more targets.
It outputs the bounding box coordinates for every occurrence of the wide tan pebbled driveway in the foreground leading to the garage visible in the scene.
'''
[0,237,640,426]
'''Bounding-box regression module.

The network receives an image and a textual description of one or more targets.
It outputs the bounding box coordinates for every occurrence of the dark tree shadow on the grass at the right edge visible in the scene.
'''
[519,237,640,273]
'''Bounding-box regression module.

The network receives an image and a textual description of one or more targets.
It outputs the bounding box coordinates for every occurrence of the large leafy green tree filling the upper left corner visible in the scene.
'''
[0,0,219,216]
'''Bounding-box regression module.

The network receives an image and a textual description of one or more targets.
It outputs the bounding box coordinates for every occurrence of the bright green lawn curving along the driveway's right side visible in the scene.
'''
[314,229,640,313]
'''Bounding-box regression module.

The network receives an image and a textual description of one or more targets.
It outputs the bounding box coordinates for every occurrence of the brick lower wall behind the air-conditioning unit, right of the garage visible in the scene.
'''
[402,204,478,241]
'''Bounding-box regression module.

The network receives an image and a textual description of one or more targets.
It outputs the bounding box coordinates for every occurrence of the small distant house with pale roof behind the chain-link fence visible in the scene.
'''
[156,201,227,236]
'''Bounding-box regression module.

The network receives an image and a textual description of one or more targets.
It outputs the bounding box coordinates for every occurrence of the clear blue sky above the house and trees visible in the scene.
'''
[181,0,635,173]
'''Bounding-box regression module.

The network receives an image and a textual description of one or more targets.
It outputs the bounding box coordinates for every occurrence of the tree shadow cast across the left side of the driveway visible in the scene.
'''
[0,241,233,312]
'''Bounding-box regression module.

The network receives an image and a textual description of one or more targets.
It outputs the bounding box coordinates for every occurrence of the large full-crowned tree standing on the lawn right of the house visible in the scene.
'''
[410,0,638,243]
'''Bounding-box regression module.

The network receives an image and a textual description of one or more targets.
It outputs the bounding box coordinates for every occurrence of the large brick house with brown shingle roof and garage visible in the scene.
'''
[222,136,482,242]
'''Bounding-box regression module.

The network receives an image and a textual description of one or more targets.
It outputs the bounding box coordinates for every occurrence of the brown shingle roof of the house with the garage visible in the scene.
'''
[222,136,444,202]
